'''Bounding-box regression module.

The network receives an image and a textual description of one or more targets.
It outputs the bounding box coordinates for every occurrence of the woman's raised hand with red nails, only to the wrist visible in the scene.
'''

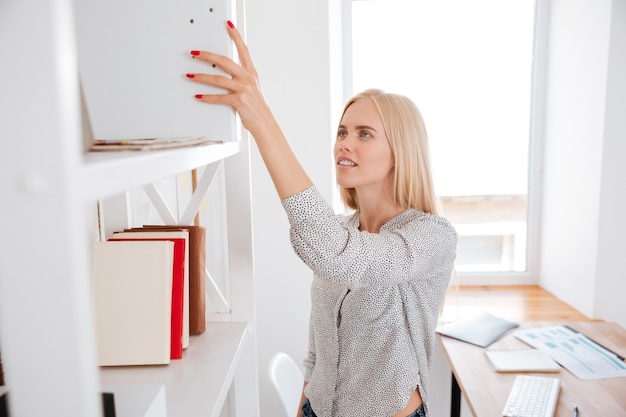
[187,21,275,136]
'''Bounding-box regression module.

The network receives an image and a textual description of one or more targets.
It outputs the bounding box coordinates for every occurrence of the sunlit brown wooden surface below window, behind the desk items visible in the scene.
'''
[441,285,589,322]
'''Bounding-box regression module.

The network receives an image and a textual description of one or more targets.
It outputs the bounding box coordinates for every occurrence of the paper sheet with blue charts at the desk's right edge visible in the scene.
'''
[513,326,626,380]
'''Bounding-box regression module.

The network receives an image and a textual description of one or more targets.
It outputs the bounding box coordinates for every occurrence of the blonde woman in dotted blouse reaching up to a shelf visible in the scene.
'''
[188,22,457,417]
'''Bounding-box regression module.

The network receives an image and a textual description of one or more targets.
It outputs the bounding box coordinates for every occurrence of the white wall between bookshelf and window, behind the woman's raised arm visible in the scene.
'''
[246,0,343,417]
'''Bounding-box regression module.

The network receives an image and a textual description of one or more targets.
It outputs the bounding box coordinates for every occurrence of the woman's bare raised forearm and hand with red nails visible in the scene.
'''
[187,21,312,200]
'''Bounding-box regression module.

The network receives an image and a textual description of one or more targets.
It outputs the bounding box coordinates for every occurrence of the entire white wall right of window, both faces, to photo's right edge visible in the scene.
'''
[540,0,626,325]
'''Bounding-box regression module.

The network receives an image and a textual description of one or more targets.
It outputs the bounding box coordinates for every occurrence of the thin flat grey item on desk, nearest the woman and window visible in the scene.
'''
[436,313,519,347]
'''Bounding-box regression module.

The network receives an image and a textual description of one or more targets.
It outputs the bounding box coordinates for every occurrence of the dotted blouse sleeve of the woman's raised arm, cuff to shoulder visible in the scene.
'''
[283,187,457,288]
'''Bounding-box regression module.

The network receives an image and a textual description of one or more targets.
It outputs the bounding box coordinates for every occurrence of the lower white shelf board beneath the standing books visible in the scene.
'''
[101,322,247,417]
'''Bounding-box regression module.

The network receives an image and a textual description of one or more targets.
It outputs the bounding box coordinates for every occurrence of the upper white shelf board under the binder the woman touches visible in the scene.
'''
[79,142,241,202]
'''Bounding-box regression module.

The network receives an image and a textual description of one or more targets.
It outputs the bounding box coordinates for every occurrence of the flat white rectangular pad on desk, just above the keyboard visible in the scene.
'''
[485,349,561,372]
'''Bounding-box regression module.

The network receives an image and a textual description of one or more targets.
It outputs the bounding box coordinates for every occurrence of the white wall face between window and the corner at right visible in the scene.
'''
[541,0,610,315]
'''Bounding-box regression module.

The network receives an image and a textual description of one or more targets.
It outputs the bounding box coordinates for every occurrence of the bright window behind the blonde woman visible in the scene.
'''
[346,0,536,283]
